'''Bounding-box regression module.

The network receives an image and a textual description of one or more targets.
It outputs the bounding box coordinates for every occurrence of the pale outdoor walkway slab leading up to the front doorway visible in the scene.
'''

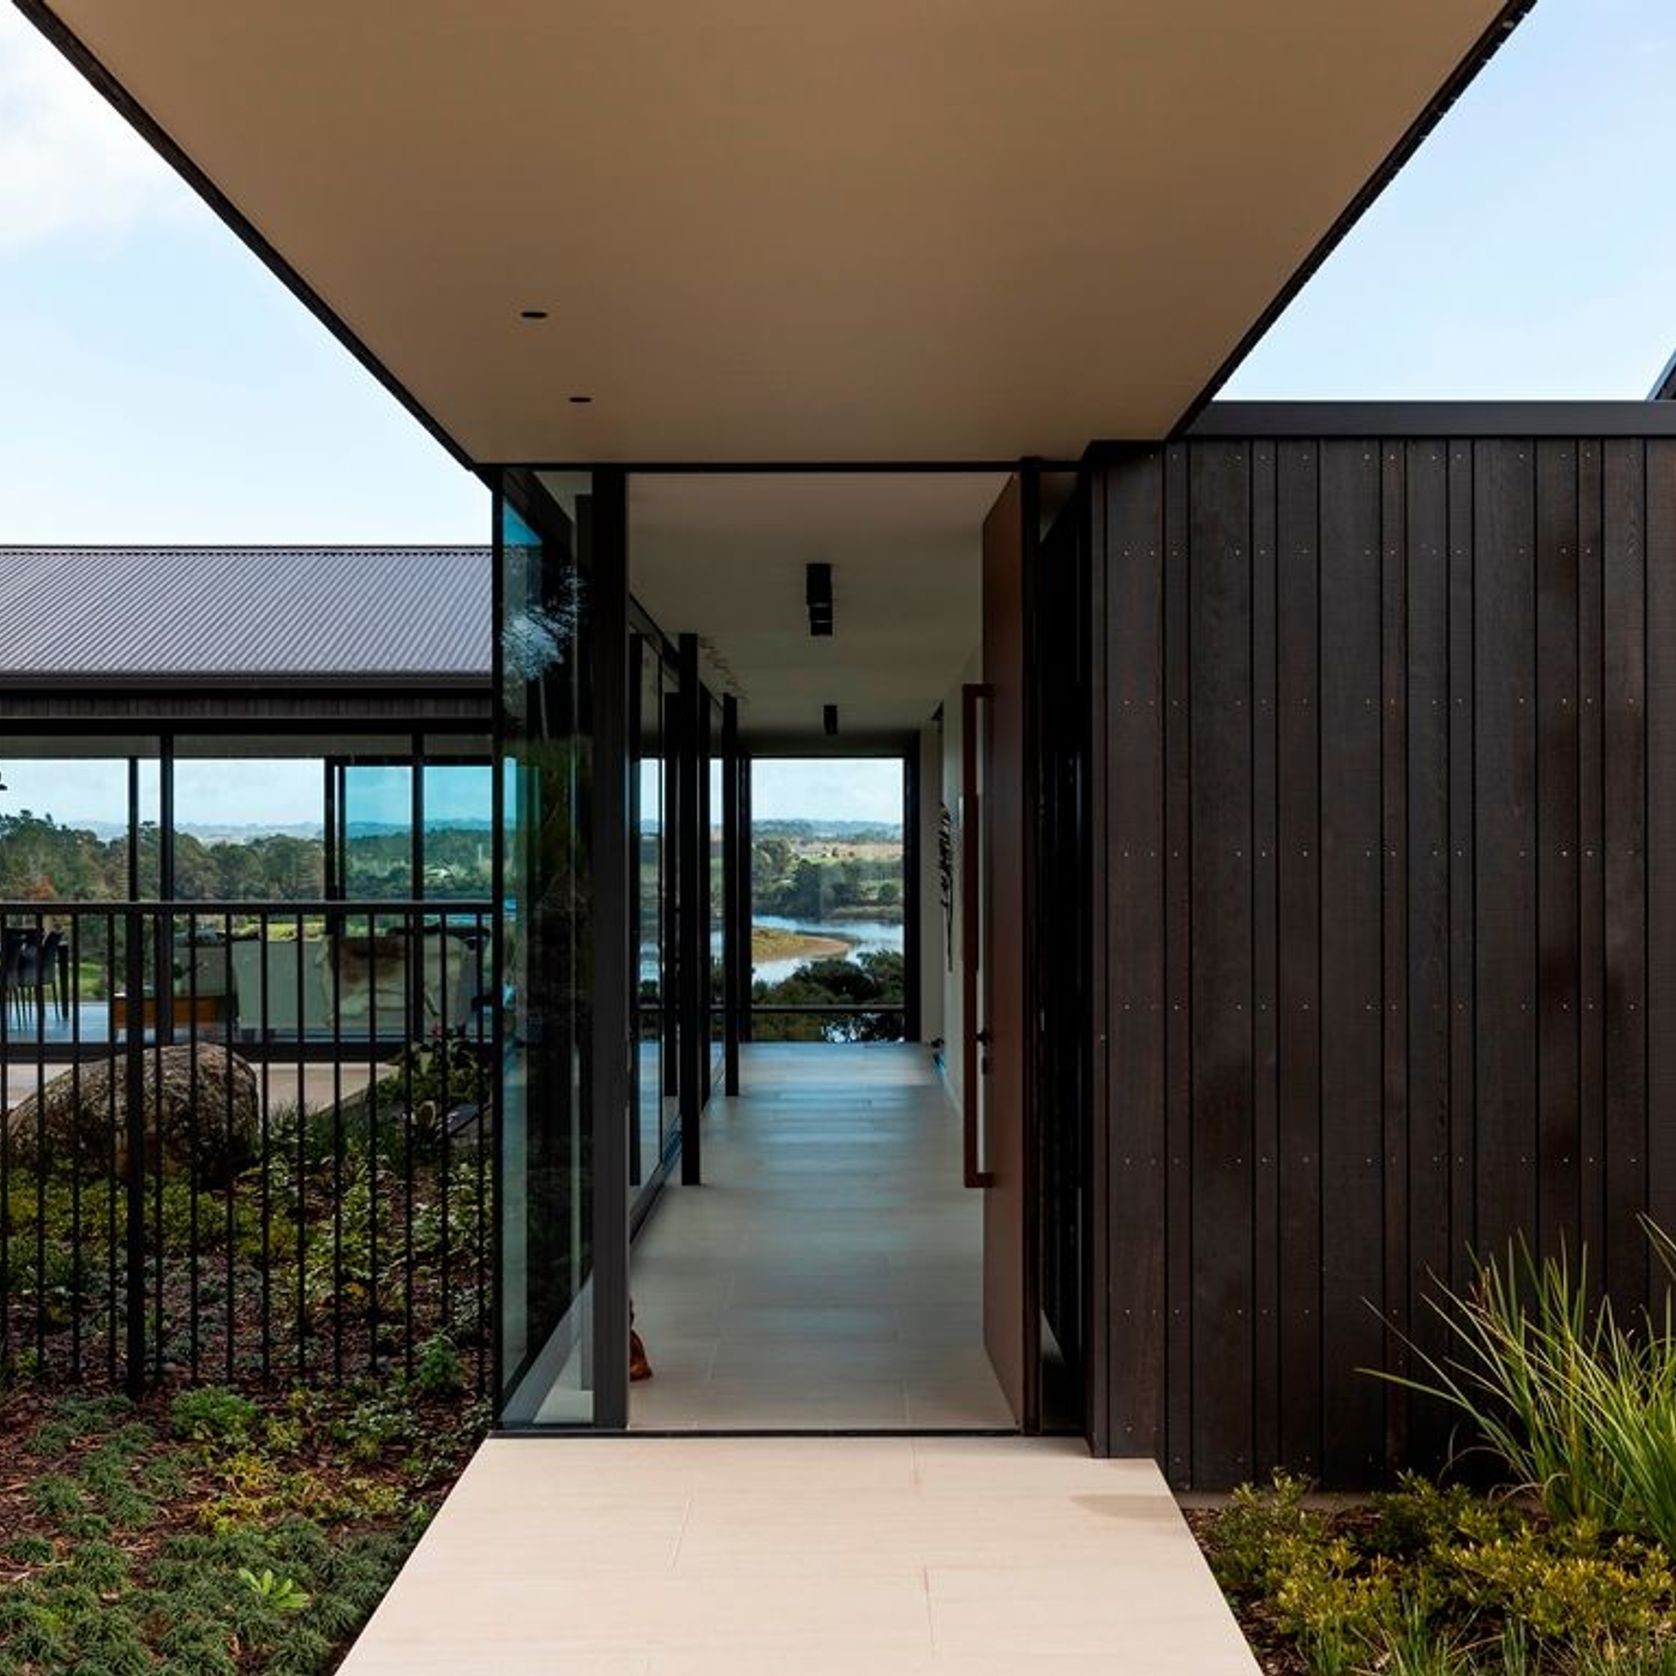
[344,1436,1257,1676]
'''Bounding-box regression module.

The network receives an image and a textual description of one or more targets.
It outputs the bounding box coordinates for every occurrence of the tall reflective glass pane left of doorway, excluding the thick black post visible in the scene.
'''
[496,474,595,1425]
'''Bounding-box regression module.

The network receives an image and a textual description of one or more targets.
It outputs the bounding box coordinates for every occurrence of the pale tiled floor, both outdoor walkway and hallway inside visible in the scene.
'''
[344,1046,1257,1676]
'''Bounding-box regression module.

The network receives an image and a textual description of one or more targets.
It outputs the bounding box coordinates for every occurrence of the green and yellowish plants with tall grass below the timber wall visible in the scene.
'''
[1197,1223,1676,1676]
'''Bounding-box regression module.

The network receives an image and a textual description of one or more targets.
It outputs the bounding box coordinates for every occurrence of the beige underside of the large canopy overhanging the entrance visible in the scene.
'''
[30,0,1498,463]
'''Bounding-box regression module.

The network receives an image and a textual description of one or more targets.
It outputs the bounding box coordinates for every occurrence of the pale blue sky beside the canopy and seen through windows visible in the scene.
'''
[0,0,1676,825]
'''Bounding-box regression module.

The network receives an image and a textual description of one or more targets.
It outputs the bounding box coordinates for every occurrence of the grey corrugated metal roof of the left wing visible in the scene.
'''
[0,546,491,684]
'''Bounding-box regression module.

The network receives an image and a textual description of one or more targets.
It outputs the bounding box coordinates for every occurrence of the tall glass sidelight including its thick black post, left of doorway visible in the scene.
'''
[496,471,632,1428]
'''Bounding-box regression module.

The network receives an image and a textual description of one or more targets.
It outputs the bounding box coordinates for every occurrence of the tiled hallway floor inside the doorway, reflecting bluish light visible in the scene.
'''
[630,1042,1012,1431]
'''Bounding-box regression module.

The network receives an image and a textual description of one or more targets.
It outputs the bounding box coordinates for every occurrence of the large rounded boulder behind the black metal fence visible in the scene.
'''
[8,1042,261,1187]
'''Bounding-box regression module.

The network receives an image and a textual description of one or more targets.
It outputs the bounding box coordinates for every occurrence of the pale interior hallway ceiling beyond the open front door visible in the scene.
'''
[629,473,1006,742]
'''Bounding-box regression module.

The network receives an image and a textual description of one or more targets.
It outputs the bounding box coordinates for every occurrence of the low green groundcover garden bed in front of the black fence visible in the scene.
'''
[0,1367,488,1676]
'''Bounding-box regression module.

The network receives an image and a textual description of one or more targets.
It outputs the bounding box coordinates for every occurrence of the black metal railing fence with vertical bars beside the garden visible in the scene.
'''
[0,900,496,1394]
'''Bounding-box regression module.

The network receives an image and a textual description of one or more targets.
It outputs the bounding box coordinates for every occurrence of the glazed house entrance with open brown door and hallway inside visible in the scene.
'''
[498,468,1088,1431]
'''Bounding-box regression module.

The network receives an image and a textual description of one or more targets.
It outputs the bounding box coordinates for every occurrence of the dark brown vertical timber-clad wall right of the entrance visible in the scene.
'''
[1091,421,1676,1487]
